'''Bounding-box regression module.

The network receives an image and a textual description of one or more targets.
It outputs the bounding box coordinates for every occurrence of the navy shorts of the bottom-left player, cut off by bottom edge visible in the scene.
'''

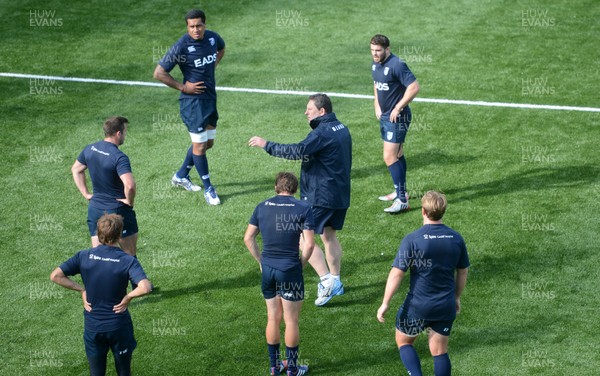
[83,323,137,376]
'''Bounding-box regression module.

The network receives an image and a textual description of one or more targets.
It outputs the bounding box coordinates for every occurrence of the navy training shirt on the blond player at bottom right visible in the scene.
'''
[392,224,470,321]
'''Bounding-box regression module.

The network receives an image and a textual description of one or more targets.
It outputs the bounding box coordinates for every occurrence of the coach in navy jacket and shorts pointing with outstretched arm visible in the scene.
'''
[248,94,352,306]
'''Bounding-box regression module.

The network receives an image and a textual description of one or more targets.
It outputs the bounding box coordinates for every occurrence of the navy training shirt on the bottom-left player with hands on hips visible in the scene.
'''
[60,245,147,332]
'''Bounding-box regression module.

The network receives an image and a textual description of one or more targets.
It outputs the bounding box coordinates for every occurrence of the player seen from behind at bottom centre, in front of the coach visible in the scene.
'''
[244,172,314,376]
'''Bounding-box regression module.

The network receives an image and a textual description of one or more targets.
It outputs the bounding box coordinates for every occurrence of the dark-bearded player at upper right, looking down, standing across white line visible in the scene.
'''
[371,34,420,213]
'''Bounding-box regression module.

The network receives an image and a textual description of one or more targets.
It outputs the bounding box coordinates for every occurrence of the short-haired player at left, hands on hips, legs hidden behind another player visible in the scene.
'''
[71,116,138,256]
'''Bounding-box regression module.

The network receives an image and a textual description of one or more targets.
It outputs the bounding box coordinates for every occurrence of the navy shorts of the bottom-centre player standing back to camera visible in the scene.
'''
[262,264,304,302]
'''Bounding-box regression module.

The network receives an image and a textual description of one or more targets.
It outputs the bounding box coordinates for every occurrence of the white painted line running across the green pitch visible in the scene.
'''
[0,72,600,112]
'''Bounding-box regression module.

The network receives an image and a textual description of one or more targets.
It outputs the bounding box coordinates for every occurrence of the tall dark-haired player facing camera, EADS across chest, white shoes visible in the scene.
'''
[154,9,225,205]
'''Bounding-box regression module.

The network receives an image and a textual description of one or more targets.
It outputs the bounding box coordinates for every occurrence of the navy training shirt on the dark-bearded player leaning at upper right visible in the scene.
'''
[371,54,417,118]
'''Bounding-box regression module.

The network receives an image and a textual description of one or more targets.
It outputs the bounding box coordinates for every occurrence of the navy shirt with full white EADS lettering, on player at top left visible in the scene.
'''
[158,30,225,100]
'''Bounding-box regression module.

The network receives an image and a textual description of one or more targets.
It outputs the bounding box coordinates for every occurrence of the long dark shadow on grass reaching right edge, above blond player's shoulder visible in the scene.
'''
[445,165,600,202]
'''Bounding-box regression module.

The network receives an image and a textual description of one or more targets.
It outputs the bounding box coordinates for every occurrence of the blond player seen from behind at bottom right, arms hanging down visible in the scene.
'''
[377,191,469,376]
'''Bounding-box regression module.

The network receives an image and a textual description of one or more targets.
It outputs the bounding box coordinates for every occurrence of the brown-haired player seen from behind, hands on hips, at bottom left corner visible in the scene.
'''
[50,214,151,376]
